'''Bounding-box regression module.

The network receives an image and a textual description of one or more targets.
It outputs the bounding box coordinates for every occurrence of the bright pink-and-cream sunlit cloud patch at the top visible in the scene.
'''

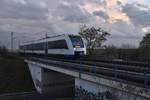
[81,0,129,23]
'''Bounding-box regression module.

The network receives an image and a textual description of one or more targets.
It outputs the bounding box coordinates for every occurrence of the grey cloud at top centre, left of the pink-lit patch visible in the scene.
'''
[52,2,90,23]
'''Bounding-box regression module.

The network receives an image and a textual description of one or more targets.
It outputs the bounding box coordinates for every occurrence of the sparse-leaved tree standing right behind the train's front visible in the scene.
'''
[79,25,110,54]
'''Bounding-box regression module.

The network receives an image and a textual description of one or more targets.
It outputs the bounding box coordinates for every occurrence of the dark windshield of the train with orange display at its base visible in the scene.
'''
[69,36,84,48]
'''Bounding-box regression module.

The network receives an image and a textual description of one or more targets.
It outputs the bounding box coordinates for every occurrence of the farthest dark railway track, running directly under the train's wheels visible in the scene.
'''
[25,55,150,68]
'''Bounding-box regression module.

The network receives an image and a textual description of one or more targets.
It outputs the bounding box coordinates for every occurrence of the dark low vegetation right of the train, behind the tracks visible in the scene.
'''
[87,48,150,62]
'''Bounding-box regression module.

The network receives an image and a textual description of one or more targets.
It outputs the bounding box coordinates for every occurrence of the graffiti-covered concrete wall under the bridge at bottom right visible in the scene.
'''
[75,78,149,100]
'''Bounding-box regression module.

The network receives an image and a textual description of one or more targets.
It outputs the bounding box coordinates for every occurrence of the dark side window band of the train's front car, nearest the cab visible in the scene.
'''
[48,40,68,49]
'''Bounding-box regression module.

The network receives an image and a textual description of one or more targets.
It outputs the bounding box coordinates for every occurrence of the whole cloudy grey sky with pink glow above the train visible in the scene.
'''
[0,0,150,47]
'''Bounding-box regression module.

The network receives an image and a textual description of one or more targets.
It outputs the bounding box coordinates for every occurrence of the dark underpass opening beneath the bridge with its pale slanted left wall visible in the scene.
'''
[28,64,75,97]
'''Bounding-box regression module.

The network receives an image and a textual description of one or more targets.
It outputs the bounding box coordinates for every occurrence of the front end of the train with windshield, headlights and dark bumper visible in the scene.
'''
[69,35,86,56]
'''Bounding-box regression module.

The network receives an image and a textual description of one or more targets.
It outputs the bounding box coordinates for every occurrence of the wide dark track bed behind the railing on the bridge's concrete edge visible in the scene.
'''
[29,58,150,88]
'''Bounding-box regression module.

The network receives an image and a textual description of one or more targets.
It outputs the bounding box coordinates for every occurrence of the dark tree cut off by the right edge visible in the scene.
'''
[139,33,150,48]
